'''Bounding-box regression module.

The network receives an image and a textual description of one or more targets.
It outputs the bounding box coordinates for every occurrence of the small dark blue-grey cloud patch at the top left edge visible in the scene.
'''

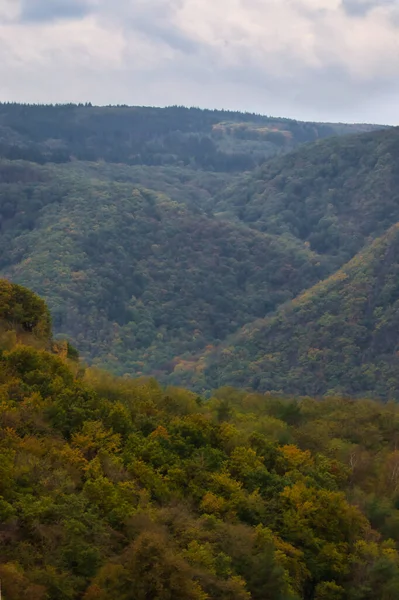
[20,0,92,23]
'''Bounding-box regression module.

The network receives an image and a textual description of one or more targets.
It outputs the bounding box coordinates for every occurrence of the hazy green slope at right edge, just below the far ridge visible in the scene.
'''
[212,128,399,264]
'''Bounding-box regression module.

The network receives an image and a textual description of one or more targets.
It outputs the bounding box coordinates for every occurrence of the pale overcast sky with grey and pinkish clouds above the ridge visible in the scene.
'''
[0,0,399,124]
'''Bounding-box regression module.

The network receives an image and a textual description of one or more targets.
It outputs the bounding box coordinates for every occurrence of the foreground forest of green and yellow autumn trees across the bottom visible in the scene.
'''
[0,280,399,600]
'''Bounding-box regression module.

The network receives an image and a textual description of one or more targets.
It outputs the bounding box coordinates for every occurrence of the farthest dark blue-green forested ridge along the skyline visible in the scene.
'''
[0,104,388,172]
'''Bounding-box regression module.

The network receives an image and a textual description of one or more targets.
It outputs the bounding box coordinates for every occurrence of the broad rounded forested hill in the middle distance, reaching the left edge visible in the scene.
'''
[0,161,326,373]
